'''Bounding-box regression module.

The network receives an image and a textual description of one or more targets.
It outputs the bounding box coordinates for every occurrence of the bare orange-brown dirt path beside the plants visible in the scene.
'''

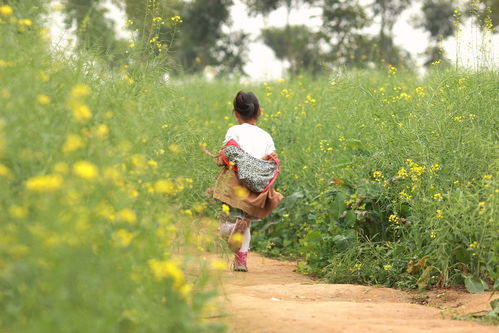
[222,253,499,333]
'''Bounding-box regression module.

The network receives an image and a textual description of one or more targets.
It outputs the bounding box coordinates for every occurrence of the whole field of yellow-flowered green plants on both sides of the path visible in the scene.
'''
[0,1,499,332]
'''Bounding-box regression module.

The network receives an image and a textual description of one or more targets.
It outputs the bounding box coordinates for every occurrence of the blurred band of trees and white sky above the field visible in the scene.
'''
[44,0,499,79]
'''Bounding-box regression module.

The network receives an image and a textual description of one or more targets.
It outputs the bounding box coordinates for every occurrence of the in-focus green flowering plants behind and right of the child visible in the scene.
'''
[169,65,499,289]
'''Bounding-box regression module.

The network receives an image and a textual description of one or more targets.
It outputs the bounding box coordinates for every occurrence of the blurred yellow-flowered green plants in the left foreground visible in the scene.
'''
[0,2,225,333]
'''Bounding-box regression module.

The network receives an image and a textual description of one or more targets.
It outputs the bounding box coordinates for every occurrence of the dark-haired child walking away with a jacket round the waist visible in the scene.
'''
[211,91,283,272]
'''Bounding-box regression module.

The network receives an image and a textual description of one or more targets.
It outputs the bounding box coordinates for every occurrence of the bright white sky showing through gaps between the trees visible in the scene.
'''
[49,0,499,80]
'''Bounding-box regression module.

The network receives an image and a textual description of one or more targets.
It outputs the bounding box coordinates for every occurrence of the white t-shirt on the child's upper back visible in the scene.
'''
[224,123,275,158]
